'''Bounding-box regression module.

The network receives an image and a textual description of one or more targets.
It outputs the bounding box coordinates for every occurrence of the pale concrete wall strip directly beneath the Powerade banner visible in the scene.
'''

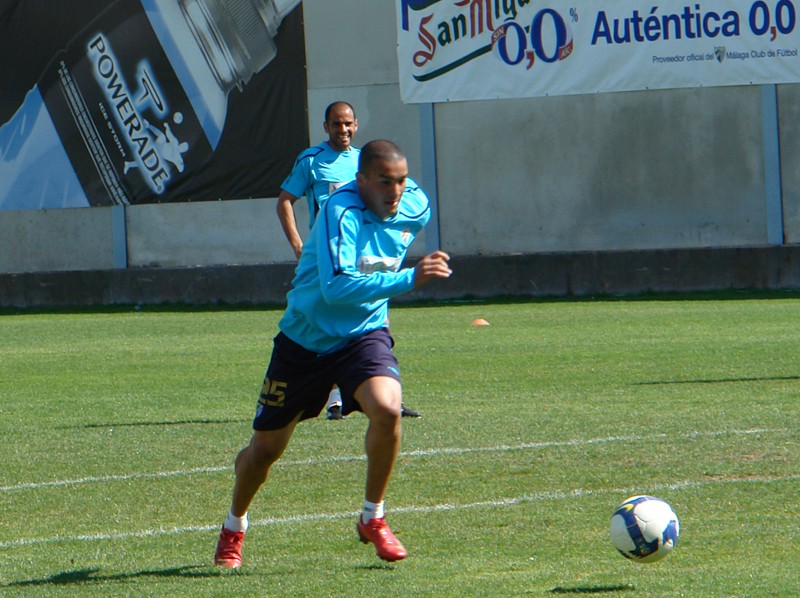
[0,199,308,273]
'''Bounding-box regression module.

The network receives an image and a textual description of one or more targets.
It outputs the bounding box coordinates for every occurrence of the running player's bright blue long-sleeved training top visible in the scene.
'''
[279,179,430,353]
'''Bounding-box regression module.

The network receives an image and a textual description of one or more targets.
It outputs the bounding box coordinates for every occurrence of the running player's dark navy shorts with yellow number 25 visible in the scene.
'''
[253,328,400,430]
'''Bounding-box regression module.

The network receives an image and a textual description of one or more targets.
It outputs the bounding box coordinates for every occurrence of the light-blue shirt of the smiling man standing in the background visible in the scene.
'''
[281,141,361,227]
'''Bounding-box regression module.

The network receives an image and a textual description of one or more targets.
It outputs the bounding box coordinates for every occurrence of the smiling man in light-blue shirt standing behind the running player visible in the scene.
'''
[277,100,421,420]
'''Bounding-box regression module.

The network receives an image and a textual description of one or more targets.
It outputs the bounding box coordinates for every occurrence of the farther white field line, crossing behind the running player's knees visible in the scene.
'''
[0,428,790,492]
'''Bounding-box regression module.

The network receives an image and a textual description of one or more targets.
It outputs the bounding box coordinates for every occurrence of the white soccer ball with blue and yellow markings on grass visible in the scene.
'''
[611,496,681,563]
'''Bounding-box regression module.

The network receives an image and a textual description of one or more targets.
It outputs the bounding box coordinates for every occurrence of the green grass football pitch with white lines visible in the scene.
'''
[0,293,800,597]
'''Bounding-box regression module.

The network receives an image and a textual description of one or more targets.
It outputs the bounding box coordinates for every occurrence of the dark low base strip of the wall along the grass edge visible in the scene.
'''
[0,245,800,308]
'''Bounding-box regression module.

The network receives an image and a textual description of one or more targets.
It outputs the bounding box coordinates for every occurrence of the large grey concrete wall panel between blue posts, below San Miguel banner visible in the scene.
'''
[436,87,767,255]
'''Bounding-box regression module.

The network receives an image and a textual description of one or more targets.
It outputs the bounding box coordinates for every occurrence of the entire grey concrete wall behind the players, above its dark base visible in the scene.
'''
[0,0,800,302]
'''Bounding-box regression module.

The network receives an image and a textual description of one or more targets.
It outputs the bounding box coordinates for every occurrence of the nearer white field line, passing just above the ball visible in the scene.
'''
[0,474,800,550]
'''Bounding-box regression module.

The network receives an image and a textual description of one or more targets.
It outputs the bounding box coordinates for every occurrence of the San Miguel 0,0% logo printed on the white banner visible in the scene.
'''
[400,0,578,82]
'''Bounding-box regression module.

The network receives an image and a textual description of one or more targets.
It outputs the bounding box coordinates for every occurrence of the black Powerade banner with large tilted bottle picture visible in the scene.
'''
[0,0,308,210]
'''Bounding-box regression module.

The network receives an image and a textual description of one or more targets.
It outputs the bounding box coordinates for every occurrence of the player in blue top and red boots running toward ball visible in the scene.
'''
[214,140,452,567]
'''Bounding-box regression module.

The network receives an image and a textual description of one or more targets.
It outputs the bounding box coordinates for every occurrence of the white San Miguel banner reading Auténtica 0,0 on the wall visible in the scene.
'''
[396,0,800,102]
